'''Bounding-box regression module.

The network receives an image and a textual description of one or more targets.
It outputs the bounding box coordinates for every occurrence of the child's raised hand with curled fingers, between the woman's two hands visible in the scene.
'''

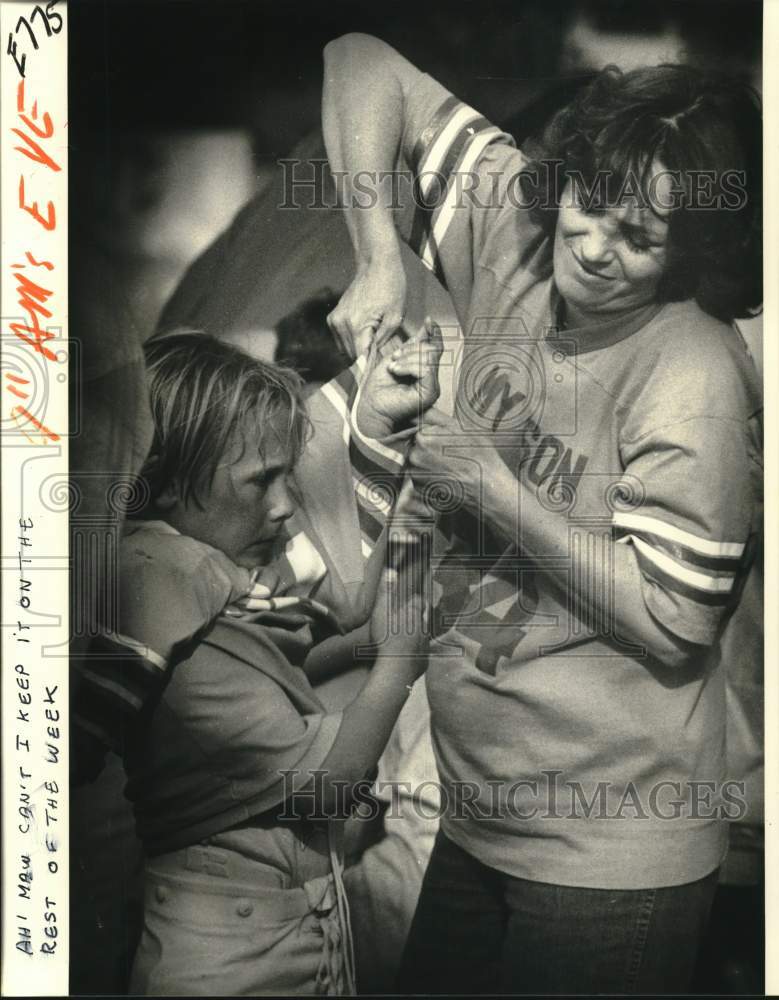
[356,316,443,438]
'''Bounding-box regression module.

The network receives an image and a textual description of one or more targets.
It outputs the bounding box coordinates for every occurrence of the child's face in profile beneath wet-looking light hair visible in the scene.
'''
[160,416,295,569]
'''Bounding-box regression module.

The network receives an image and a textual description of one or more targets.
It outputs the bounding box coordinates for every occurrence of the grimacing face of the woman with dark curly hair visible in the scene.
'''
[554,164,669,326]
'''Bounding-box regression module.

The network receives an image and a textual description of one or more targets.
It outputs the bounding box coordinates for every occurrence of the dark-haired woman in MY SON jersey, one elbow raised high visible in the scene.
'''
[323,35,761,993]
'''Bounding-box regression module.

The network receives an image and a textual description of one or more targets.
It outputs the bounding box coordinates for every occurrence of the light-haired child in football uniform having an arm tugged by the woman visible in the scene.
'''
[76,331,438,996]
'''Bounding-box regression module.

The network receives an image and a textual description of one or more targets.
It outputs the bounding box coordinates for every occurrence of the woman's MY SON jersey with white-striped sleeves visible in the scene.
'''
[398,74,761,889]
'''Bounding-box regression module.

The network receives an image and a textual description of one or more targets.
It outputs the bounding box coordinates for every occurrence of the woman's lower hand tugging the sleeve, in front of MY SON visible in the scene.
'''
[408,409,507,513]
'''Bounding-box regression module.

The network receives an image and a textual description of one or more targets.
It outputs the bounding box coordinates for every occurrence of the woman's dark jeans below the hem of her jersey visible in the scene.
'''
[398,833,717,994]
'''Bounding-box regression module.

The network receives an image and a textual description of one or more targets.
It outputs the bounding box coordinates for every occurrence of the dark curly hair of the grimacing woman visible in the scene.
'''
[522,65,763,321]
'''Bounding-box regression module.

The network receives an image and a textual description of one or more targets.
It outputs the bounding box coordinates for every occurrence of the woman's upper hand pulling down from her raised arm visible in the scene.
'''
[327,247,406,358]
